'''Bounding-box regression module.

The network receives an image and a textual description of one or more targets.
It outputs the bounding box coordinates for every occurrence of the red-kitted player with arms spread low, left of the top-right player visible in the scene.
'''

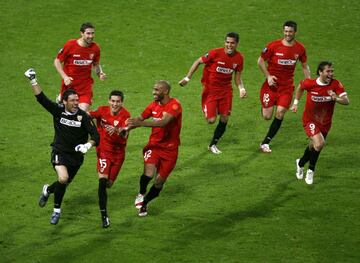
[179,32,247,154]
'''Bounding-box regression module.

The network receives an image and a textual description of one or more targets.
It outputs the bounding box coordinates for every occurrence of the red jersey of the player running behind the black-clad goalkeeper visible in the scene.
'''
[57,39,100,82]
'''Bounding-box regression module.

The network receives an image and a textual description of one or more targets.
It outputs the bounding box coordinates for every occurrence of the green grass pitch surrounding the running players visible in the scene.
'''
[0,0,360,262]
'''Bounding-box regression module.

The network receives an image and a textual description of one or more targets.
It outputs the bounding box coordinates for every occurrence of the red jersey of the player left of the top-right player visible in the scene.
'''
[201,48,244,95]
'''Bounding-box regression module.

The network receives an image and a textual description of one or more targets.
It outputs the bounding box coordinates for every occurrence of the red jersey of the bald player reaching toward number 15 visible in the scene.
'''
[141,98,182,149]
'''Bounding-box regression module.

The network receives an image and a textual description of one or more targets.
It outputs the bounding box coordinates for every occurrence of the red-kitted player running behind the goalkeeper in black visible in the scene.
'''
[54,23,106,111]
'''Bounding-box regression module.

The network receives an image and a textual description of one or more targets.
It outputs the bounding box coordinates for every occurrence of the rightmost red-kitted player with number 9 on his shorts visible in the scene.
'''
[291,61,349,184]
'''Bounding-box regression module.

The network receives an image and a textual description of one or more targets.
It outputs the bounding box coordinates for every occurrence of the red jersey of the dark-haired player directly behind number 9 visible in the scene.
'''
[261,39,307,86]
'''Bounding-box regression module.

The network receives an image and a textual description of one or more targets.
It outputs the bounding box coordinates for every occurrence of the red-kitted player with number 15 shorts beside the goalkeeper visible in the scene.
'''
[89,90,130,228]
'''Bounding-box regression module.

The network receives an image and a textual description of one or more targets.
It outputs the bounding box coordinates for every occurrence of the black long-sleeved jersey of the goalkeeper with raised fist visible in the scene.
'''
[36,92,100,153]
